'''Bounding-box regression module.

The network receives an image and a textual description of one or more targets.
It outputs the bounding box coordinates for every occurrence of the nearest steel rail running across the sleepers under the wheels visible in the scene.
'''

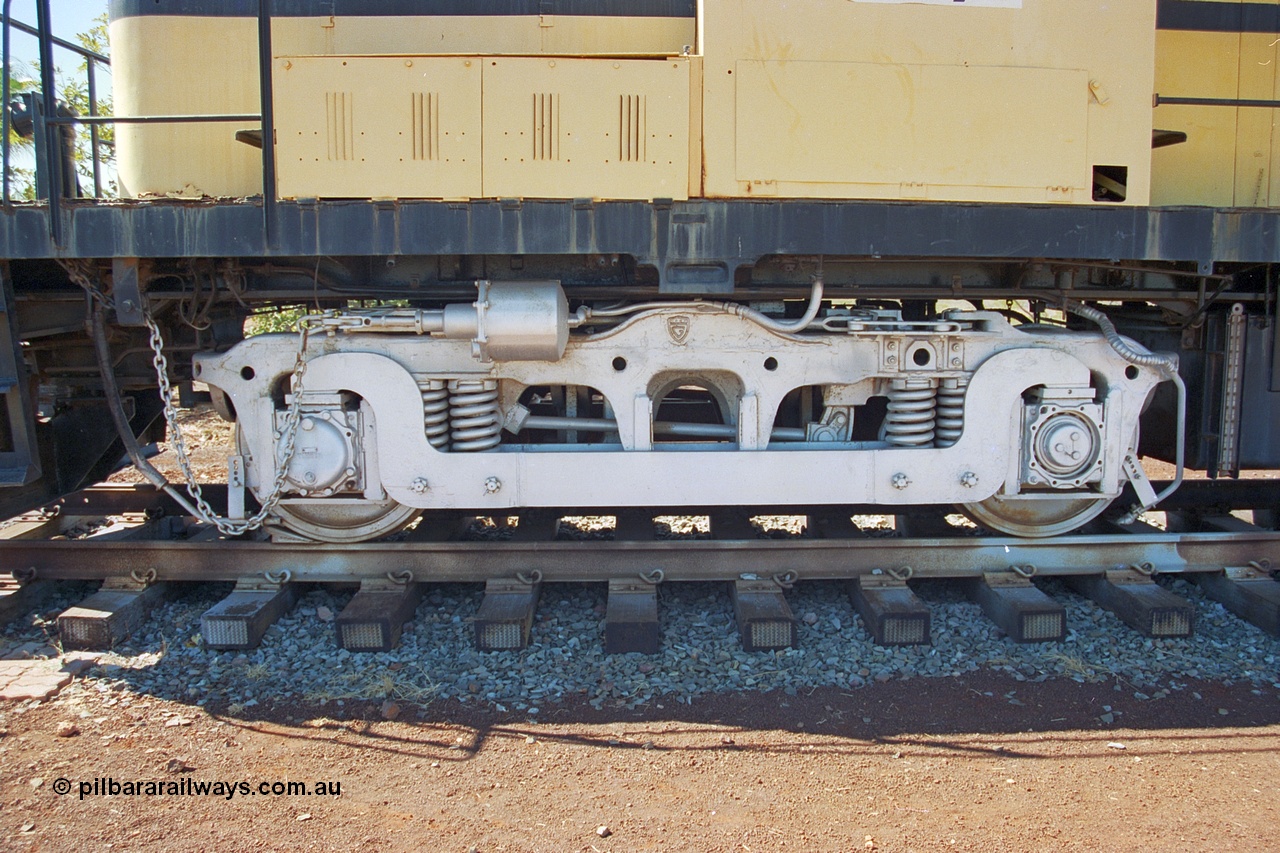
[0,529,1280,583]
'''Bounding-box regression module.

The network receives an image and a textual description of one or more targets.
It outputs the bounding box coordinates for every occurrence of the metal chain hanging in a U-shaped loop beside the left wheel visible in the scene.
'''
[142,306,308,537]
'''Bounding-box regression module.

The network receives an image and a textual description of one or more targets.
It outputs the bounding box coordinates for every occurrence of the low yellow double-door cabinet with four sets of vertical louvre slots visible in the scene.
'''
[275,56,691,199]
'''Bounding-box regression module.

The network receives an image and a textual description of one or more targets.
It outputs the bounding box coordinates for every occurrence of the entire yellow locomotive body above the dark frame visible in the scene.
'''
[111,0,1259,206]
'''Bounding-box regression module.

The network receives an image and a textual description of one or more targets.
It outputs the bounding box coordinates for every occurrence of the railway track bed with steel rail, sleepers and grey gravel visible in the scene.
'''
[0,487,1280,713]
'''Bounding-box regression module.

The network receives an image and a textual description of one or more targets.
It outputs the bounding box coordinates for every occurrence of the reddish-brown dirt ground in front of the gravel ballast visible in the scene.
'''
[0,674,1280,853]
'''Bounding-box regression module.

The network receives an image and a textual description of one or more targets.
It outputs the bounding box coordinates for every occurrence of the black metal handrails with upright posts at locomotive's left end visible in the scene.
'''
[0,0,276,245]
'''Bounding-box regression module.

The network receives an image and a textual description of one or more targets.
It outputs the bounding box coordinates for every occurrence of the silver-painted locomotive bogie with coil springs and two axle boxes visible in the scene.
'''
[196,283,1164,537]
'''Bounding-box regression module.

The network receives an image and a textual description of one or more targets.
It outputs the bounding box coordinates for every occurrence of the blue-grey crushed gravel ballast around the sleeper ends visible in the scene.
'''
[0,568,1280,717]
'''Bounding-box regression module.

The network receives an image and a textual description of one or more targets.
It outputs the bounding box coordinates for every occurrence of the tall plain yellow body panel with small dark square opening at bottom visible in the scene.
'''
[704,0,1156,204]
